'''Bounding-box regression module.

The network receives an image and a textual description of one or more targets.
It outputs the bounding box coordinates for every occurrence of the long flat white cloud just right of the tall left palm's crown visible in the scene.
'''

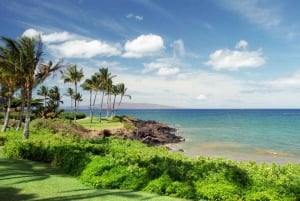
[48,40,121,58]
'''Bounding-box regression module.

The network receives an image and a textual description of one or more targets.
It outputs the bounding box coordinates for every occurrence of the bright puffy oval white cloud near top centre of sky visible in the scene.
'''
[122,34,164,58]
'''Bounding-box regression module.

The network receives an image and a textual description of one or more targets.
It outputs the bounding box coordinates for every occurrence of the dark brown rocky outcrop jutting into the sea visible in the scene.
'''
[102,119,185,146]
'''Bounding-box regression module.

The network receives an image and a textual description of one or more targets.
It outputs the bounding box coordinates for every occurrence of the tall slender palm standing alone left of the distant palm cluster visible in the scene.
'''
[62,65,84,122]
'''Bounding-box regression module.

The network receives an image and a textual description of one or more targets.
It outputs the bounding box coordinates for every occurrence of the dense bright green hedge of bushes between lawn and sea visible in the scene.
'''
[0,127,300,201]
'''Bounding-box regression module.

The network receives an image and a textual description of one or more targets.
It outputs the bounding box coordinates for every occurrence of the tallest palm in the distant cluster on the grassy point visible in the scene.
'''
[96,68,115,122]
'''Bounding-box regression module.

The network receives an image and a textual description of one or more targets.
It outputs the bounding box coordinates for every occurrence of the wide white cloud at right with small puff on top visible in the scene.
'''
[205,40,266,71]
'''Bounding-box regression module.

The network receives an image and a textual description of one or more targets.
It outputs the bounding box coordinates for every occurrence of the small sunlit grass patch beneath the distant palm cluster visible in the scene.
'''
[77,117,123,129]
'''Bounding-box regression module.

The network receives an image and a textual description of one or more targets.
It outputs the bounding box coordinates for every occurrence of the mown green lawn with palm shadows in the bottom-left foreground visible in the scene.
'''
[0,147,188,201]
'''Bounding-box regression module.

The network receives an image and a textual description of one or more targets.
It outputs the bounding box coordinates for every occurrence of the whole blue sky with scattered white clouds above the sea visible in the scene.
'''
[0,0,300,108]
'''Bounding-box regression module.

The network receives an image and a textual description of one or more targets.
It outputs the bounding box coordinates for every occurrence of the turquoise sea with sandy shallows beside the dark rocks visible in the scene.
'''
[79,109,300,164]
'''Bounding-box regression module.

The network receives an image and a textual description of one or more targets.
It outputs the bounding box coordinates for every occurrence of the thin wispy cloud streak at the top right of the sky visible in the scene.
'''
[223,0,281,28]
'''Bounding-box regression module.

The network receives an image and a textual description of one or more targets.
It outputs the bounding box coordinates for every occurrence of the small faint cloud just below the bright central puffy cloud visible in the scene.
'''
[143,58,180,76]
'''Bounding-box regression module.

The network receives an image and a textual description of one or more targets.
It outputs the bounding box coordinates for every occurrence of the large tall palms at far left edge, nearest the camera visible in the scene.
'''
[0,37,63,139]
